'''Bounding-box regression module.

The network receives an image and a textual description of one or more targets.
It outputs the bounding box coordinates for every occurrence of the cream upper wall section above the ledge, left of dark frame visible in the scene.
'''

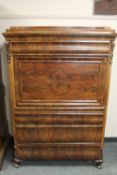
[0,0,93,17]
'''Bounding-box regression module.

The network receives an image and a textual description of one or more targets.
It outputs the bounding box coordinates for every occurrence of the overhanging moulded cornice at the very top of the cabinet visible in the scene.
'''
[3,26,116,37]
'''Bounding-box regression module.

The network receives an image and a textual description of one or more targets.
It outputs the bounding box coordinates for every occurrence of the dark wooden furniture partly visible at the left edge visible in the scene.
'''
[0,53,9,170]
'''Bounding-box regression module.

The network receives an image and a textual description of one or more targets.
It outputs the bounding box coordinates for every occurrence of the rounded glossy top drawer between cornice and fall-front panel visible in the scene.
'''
[11,41,112,55]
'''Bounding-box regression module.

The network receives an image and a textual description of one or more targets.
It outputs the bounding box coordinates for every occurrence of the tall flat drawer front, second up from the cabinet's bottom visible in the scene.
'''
[15,124,102,143]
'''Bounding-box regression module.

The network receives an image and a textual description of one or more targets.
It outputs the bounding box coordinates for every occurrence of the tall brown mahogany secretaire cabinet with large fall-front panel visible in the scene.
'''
[4,27,116,167]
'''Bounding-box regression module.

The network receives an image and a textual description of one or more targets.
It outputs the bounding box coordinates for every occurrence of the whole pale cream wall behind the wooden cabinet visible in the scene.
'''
[0,0,117,137]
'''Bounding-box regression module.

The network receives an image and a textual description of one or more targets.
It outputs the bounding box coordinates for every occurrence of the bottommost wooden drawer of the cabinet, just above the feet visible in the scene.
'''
[16,144,102,160]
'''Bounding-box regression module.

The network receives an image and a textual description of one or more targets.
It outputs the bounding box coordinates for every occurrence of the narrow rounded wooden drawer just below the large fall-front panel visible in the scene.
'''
[15,114,103,124]
